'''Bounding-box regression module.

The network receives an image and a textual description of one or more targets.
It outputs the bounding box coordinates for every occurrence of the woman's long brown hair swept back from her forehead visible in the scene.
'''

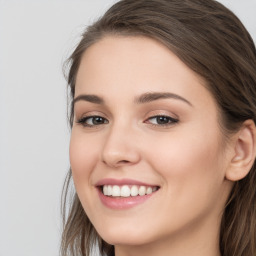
[61,0,256,256]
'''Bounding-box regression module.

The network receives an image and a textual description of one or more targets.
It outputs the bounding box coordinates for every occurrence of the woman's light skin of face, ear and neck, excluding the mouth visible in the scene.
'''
[70,36,255,256]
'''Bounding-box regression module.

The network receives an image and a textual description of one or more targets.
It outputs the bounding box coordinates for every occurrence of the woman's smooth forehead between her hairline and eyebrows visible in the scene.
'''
[75,36,213,107]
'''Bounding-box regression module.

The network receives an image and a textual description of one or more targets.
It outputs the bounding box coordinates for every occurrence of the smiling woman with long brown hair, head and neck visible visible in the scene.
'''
[62,0,256,256]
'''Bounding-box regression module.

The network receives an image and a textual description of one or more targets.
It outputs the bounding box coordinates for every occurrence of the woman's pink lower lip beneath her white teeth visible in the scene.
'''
[98,189,156,210]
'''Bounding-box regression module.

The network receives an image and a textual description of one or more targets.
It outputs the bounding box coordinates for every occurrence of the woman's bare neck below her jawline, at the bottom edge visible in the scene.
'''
[115,215,221,256]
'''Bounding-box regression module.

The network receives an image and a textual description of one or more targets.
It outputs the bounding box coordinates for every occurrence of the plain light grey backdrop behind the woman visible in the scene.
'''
[0,0,256,256]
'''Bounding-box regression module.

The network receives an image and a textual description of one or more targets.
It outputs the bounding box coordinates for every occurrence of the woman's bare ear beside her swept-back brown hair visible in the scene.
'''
[226,120,256,181]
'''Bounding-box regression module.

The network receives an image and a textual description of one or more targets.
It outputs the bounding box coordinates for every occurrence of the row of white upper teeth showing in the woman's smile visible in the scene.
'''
[103,185,157,197]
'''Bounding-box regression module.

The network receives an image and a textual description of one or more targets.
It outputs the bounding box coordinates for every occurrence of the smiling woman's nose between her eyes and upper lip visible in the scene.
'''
[102,125,140,168]
